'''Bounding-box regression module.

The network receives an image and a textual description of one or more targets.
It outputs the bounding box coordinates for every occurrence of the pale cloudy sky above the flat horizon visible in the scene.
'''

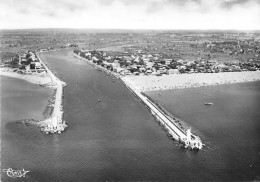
[0,0,260,30]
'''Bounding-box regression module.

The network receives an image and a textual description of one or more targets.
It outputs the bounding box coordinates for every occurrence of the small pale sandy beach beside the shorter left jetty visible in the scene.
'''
[0,68,52,85]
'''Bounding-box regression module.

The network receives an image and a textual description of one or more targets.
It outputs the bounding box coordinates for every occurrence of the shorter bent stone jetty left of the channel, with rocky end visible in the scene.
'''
[36,53,68,134]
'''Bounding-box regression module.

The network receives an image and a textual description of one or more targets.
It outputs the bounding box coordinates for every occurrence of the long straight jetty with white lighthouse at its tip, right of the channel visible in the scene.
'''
[72,53,204,149]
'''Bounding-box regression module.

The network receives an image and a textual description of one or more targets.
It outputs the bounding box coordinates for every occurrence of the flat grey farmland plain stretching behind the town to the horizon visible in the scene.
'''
[0,29,260,61]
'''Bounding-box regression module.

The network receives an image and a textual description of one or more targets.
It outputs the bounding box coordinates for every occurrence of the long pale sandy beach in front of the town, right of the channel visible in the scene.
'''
[124,71,260,91]
